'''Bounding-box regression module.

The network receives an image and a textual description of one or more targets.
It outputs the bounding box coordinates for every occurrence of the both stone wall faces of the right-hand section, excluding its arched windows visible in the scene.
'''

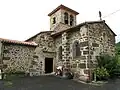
[55,22,115,80]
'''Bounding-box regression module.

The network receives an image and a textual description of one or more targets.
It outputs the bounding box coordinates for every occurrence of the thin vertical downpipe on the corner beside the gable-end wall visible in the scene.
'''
[86,23,91,82]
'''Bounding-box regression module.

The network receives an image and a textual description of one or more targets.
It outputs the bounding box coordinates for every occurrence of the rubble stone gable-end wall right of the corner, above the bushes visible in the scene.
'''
[88,22,115,67]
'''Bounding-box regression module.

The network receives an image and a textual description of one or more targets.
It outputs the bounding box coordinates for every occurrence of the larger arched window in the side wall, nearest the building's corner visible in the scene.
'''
[73,41,81,58]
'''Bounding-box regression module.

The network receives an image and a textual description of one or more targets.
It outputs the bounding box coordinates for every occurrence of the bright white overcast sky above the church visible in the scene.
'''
[0,0,120,42]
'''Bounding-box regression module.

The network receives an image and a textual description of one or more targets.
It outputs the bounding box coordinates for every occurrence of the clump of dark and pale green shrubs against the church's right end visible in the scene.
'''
[95,55,120,79]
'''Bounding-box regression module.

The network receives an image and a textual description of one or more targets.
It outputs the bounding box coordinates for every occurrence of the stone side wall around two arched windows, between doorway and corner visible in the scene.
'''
[55,26,88,80]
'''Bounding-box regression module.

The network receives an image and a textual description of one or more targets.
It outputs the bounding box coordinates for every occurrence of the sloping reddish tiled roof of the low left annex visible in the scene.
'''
[0,38,37,46]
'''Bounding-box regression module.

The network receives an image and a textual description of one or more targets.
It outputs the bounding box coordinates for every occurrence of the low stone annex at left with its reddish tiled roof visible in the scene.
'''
[0,38,37,73]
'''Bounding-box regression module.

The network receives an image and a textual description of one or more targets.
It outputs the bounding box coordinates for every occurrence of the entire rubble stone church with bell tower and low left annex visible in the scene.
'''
[0,5,116,81]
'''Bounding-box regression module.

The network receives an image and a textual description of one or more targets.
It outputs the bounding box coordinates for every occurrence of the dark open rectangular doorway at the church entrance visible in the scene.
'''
[45,58,53,74]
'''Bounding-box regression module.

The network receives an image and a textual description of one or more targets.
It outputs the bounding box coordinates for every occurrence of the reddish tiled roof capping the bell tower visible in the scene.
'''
[48,4,79,16]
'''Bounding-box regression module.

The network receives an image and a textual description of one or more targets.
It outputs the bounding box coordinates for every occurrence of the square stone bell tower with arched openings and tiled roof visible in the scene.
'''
[48,5,79,32]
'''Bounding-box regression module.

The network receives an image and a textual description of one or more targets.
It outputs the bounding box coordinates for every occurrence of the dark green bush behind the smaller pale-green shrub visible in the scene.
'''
[97,54,120,77]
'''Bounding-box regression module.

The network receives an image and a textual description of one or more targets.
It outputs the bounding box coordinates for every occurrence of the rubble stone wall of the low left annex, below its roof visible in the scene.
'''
[2,43,35,73]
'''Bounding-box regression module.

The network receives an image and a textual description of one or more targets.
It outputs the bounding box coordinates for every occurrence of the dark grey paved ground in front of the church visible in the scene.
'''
[0,76,120,90]
